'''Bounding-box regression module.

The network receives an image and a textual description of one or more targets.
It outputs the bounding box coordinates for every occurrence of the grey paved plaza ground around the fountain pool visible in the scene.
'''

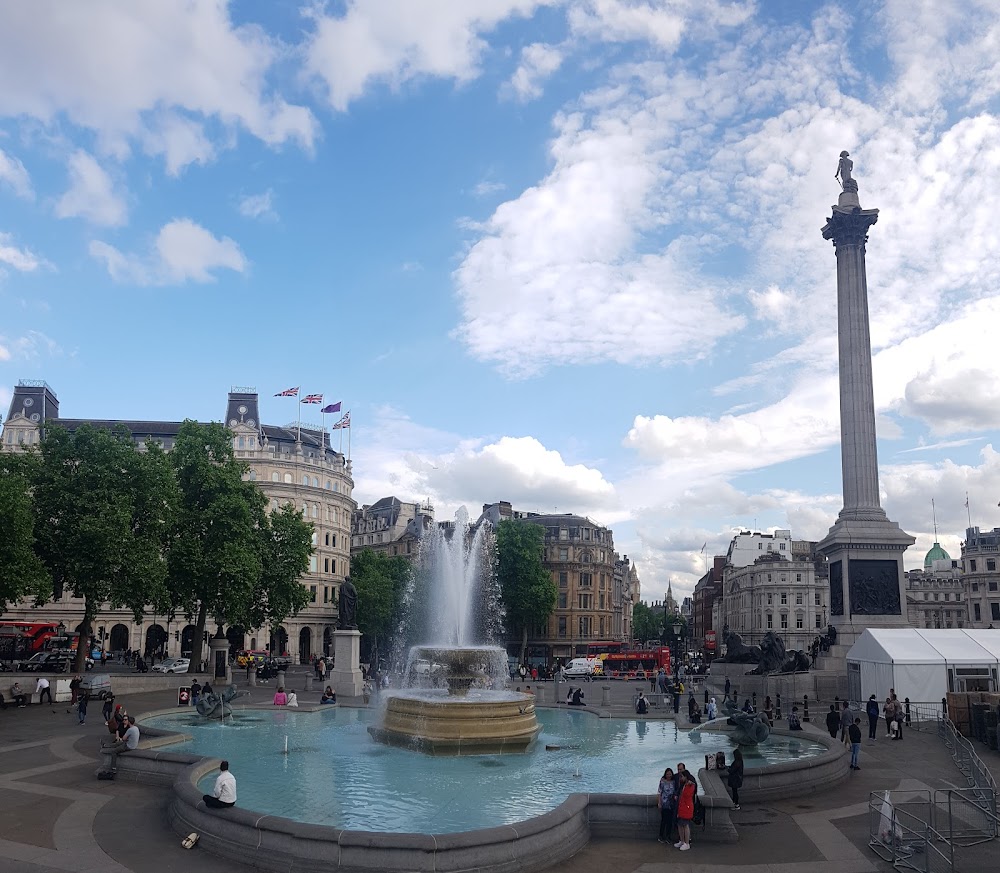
[0,683,1000,873]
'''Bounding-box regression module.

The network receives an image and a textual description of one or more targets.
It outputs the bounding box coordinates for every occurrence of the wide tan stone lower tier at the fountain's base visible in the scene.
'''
[368,691,541,755]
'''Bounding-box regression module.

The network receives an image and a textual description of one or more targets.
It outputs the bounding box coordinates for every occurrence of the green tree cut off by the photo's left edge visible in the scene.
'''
[0,453,52,614]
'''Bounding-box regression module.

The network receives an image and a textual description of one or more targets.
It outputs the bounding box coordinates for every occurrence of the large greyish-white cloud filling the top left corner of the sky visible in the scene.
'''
[0,0,316,172]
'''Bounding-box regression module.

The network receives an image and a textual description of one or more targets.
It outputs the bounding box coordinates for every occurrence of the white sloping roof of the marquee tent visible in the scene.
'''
[847,628,1000,664]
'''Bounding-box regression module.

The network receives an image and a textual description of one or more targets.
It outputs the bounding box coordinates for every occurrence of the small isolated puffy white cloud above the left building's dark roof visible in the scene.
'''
[90,218,247,285]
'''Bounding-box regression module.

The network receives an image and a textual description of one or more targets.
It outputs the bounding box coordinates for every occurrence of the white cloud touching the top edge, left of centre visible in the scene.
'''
[306,0,560,111]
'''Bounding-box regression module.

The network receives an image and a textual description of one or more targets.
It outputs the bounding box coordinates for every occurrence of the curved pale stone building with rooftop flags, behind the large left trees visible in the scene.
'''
[0,381,355,662]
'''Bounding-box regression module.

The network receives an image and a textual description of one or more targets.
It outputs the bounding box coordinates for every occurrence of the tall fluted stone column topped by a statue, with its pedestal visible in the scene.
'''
[818,152,914,652]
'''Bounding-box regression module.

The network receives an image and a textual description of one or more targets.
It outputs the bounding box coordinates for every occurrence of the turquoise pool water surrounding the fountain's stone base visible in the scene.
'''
[150,708,825,833]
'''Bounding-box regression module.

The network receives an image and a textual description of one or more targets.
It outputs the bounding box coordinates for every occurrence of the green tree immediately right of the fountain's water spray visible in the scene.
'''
[497,519,558,663]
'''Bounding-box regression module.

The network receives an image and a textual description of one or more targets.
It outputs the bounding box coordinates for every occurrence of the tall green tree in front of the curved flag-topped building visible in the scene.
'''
[168,421,313,672]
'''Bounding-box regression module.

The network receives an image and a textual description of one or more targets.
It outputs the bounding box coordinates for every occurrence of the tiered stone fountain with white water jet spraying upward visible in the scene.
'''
[368,507,541,755]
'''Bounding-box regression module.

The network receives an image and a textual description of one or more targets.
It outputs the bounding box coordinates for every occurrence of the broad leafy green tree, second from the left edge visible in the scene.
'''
[34,425,176,671]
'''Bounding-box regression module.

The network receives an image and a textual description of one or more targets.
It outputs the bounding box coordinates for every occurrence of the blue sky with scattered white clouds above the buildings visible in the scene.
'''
[0,0,1000,599]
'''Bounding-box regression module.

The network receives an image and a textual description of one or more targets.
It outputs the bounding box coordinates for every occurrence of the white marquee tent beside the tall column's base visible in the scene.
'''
[847,628,1000,705]
